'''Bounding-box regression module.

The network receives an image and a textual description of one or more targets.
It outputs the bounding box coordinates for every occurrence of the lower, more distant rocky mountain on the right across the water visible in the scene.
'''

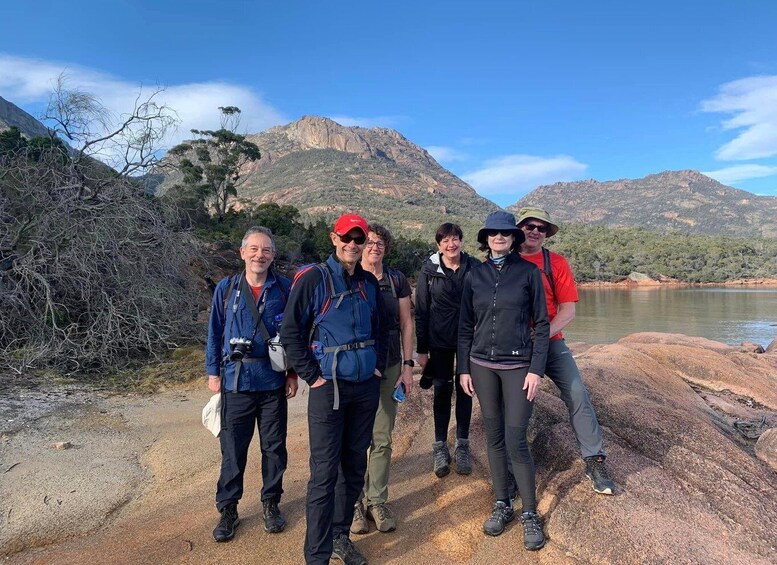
[508,170,777,237]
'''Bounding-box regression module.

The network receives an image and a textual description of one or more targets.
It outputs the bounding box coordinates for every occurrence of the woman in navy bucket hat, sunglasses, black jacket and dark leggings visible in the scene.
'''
[457,211,550,549]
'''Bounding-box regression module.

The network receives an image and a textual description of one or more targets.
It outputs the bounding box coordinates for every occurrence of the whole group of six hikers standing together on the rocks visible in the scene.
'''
[206,208,615,565]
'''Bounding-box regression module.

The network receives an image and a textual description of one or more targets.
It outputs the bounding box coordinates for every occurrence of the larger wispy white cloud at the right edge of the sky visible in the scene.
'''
[701,75,777,161]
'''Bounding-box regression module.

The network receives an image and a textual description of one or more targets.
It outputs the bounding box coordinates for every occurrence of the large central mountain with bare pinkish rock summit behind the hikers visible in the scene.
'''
[158,116,498,237]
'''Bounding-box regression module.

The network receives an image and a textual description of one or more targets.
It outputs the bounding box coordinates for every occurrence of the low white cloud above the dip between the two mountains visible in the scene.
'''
[461,155,588,196]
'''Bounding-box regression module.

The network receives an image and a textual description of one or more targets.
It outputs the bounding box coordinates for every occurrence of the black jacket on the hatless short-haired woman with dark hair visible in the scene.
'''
[415,253,480,353]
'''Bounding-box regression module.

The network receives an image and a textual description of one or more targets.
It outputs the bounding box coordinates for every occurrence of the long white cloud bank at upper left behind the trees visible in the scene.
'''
[0,53,290,148]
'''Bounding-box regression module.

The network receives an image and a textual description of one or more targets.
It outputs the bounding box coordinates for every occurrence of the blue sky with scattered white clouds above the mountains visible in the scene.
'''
[0,0,777,205]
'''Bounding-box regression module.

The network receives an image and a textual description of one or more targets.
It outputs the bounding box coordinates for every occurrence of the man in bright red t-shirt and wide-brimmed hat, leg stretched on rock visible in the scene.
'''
[518,208,615,494]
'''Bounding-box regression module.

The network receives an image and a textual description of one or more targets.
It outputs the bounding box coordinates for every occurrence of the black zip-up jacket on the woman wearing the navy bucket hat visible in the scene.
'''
[456,253,550,376]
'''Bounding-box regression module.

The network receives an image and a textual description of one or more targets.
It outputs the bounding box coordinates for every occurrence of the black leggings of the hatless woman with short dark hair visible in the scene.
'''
[429,349,472,441]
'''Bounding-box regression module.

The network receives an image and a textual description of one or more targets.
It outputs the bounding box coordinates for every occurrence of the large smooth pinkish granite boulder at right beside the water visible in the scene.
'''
[516,335,777,563]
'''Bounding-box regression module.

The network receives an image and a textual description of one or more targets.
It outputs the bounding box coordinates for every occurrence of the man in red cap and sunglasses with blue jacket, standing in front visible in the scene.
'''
[281,214,390,565]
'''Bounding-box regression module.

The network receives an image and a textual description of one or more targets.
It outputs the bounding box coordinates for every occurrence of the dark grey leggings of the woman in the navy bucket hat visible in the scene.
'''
[470,363,537,512]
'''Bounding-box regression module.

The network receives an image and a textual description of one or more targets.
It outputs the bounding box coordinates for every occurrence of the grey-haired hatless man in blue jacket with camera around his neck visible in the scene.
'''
[205,227,297,541]
